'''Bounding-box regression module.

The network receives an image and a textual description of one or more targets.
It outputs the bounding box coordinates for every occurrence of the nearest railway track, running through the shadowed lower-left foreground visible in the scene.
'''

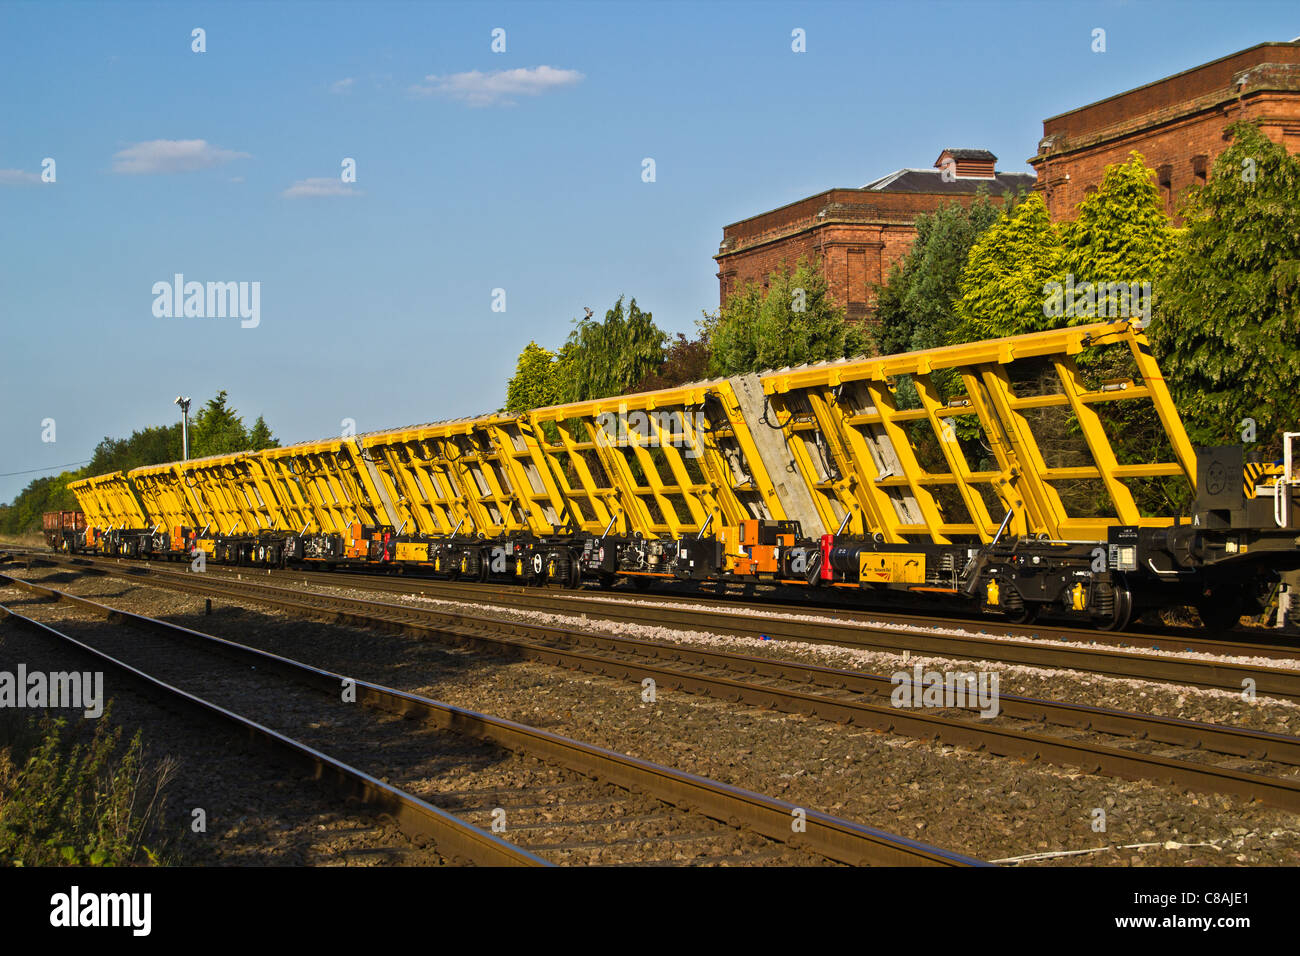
[0,576,979,866]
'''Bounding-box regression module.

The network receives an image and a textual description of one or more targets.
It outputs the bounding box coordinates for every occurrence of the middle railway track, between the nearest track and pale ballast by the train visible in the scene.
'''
[10,568,1300,809]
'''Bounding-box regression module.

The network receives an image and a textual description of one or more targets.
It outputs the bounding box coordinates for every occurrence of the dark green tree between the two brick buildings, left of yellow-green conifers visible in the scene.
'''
[871,193,1000,355]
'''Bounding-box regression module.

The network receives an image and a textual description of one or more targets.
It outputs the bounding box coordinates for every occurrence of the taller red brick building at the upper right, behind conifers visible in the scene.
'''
[1028,40,1300,219]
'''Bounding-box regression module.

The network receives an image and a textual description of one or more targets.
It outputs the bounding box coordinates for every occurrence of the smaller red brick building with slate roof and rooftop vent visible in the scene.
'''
[714,150,1034,317]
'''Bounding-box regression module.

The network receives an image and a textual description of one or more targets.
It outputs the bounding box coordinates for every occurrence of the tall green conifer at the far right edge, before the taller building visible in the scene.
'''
[1152,122,1300,453]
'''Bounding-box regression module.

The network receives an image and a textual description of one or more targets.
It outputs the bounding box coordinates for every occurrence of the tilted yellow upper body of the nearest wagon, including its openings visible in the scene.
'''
[762,323,1196,544]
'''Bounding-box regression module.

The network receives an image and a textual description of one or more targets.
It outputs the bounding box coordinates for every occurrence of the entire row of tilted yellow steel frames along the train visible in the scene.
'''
[72,321,1196,554]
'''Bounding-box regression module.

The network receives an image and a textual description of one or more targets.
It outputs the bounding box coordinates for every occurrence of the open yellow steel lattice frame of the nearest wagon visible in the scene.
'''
[762,323,1196,544]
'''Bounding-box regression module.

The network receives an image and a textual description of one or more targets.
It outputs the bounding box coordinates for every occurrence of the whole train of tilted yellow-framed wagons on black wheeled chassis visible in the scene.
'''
[56,321,1300,630]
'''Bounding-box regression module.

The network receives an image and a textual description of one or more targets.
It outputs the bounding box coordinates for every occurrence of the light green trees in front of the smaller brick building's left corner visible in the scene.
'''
[702,256,867,375]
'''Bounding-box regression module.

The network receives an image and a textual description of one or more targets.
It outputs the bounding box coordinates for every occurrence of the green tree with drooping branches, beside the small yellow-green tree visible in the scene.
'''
[555,295,668,402]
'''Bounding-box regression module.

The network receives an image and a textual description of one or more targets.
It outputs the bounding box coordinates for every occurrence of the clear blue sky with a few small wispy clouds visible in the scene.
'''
[0,0,1300,501]
